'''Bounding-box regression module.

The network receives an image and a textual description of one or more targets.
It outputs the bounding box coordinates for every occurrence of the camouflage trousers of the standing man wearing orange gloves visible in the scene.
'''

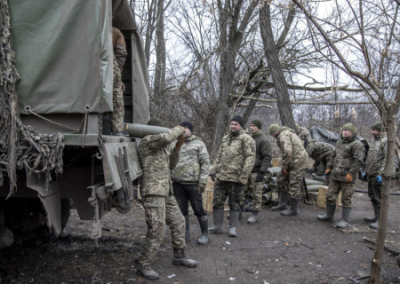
[326,178,354,208]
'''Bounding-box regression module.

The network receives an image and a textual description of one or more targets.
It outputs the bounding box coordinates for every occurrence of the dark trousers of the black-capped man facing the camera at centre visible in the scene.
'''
[213,179,246,211]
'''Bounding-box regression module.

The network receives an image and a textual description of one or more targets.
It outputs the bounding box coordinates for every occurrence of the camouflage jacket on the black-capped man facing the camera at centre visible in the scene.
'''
[210,129,256,185]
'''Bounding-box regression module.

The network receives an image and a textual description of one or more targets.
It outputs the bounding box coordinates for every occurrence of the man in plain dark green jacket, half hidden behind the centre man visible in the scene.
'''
[239,119,272,224]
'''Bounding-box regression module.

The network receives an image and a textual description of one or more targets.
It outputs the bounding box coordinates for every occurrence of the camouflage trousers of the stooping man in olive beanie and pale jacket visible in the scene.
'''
[276,170,306,199]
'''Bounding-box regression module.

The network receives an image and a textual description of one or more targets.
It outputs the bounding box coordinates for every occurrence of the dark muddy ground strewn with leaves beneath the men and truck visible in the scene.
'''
[0,182,400,284]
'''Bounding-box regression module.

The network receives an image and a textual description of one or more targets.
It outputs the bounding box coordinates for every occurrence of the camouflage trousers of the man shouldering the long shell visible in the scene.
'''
[138,195,186,268]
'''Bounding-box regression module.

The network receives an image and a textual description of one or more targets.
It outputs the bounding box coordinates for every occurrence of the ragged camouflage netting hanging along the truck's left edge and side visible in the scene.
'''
[0,0,64,197]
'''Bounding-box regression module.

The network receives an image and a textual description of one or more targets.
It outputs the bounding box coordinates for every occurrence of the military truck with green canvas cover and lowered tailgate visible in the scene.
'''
[0,0,149,248]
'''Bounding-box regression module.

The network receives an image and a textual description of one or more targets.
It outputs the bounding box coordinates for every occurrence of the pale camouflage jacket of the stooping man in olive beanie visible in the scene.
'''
[277,126,309,171]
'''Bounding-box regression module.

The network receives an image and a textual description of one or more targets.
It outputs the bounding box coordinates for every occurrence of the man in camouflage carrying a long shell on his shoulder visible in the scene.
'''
[137,117,197,280]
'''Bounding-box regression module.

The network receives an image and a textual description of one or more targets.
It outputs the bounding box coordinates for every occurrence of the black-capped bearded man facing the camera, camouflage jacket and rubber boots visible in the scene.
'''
[209,115,255,237]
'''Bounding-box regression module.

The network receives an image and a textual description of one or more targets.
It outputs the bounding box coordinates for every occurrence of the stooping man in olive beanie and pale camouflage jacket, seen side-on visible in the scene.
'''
[268,124,308,216]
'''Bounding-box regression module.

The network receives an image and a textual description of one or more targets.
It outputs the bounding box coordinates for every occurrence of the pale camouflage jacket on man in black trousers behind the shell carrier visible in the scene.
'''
[171,135,210,184]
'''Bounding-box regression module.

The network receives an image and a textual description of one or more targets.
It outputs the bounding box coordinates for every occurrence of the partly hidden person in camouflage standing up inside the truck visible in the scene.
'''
[110,27,127,135]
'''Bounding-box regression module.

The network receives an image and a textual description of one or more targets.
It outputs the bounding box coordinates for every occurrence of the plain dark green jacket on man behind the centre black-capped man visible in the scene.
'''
[251,131,272,173]
